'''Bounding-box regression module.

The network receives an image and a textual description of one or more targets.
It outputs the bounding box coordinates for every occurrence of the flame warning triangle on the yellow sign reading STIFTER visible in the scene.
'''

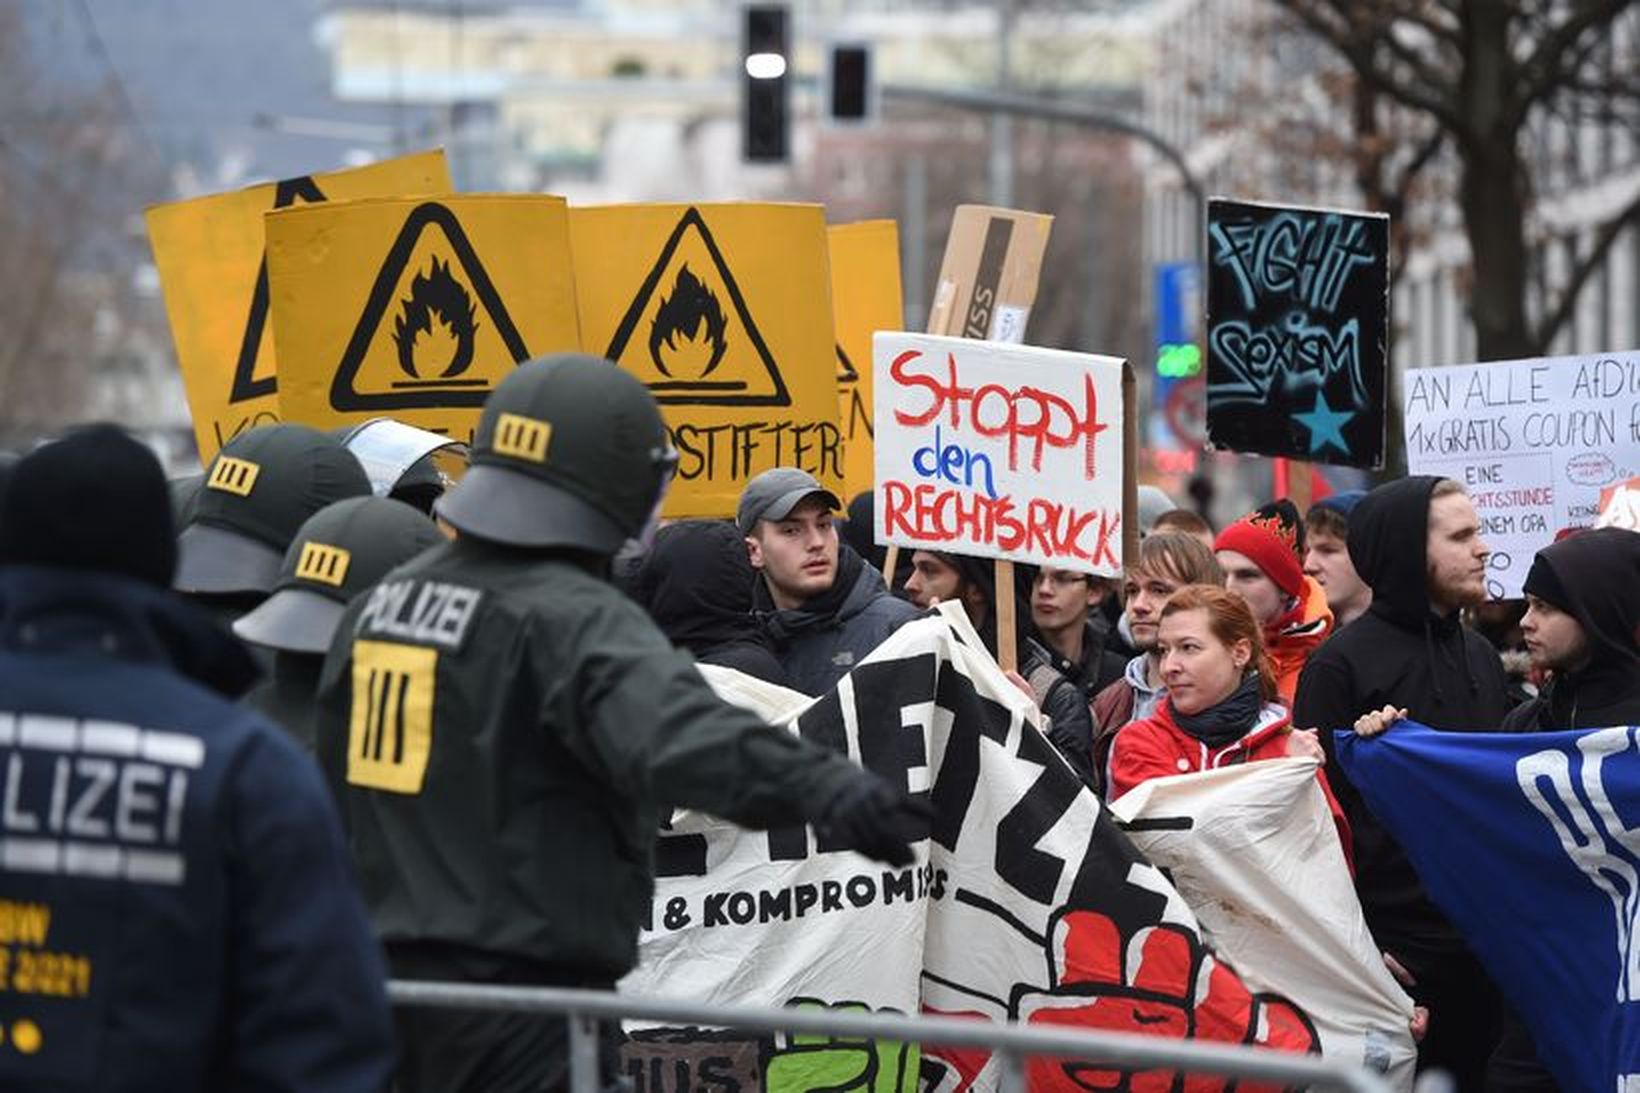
[604,207,792,405]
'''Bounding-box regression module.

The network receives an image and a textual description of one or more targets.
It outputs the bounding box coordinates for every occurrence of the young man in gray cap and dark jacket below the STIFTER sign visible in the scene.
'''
[735,466,920,694]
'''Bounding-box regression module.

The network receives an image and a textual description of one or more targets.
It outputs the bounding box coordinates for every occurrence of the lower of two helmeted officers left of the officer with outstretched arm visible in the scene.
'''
[233,497,444,752]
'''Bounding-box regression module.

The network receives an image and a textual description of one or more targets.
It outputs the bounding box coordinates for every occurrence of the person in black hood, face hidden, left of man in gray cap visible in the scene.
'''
[628,520,790,688]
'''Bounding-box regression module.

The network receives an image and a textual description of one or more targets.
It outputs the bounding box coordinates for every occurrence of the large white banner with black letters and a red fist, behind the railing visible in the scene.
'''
[622,606,1325,1093]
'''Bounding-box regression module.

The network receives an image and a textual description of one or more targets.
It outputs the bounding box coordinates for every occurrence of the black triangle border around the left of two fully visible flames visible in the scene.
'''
[330,202,530,410]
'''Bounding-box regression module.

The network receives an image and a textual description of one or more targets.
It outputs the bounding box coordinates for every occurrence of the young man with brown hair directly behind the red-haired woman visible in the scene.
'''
[1092,532,1225,791]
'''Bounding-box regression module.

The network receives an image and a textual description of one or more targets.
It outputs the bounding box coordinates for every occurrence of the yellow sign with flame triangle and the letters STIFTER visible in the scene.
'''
[569,204,843,517]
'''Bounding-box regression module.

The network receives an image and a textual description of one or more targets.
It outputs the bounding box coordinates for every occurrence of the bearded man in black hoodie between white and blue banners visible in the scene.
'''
[1292,476,1509,1090]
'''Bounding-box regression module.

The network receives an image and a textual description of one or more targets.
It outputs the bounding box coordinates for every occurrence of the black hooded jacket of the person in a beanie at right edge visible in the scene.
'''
[1504,527,1640,732]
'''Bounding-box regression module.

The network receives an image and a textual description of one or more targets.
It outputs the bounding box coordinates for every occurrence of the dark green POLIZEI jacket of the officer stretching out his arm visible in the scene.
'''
[317,540,861,978]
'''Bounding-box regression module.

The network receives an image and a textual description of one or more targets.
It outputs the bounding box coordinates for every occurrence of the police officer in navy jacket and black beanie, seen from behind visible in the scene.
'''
[0,425,392,1091]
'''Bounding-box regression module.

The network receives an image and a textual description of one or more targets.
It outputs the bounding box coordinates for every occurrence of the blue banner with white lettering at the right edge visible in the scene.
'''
[1338,722,1640,1090]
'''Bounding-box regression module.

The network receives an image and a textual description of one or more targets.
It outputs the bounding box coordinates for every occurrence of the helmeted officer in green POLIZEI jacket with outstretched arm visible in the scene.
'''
[318,354,928,1093]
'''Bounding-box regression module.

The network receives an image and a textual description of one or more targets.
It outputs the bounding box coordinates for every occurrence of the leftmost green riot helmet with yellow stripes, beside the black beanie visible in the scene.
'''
[174,423,371,622]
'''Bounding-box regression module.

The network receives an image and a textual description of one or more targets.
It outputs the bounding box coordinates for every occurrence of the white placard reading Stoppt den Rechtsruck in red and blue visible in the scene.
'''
[872,332,1135,574]
